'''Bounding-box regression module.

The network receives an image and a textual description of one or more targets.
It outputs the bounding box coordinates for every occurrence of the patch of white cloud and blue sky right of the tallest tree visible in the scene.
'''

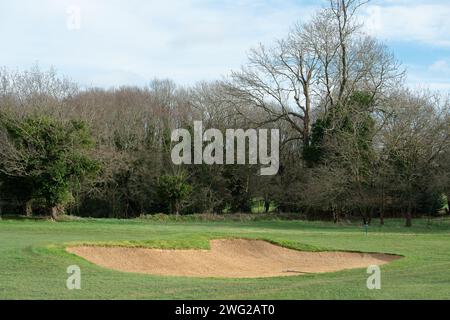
[362,0,450,92]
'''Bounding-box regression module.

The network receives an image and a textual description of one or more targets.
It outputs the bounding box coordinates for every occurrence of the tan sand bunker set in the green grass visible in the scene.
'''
[67,239,399,278]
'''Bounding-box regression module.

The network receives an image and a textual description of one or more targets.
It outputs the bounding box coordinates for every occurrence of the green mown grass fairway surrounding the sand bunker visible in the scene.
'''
[0,219,450,299]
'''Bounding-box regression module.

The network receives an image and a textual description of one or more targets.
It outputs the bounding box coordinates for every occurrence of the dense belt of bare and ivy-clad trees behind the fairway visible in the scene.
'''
[0,0,450,226]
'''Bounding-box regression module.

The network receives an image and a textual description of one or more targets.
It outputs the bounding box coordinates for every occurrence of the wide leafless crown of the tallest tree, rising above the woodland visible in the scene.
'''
[227,0,403,152]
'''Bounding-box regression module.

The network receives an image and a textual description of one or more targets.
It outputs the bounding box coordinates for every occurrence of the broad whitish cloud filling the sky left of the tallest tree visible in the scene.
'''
[0,0,318,86]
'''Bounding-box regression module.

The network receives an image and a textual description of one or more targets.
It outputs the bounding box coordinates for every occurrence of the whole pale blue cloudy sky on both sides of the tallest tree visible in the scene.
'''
[0,0,450,92]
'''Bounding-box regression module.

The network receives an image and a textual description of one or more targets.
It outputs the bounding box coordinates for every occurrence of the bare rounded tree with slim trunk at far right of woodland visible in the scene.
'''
[382,90,450,227]
